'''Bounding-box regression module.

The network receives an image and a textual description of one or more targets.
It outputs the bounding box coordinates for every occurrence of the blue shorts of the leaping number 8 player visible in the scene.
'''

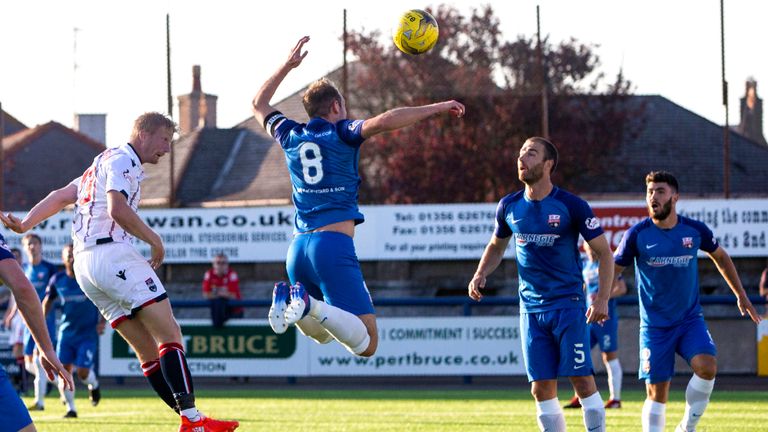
[285,231,375,315]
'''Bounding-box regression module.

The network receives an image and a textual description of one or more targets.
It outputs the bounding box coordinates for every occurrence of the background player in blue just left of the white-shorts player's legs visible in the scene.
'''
[43,244,106,418]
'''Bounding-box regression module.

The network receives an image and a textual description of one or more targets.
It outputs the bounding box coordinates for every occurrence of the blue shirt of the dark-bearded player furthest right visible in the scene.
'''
[614,216,718,327]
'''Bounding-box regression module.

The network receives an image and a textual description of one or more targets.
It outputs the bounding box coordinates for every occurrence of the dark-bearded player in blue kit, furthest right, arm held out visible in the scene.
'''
[615,171,760,432]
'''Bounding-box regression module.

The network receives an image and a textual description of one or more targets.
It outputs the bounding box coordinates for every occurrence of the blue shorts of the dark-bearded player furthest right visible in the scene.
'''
[638,315,717,384]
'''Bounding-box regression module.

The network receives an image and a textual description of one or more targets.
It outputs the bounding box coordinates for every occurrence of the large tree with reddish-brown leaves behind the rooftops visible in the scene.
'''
[347,6,642,203]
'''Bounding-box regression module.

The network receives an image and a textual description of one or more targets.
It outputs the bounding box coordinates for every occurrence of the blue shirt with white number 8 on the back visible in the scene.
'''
[274,118,365,232]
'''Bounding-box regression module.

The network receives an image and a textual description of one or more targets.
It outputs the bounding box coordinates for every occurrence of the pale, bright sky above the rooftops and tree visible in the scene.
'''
[0,0,768,145]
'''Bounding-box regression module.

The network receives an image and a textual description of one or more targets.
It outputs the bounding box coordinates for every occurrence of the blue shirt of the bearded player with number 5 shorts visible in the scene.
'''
[494,187,603,312]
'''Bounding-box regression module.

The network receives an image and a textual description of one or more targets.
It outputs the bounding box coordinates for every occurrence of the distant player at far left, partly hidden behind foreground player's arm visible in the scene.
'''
[21,233,57,411]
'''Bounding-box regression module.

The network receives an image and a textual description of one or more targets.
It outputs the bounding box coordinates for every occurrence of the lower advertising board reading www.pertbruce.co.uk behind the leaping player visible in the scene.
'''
[99,316,525,377]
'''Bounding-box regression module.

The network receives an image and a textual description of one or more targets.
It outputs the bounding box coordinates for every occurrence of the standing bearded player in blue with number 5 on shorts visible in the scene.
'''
[468,137,614,431]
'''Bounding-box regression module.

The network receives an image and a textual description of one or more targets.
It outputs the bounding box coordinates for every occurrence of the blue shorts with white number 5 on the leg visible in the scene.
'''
[520,307,593,381]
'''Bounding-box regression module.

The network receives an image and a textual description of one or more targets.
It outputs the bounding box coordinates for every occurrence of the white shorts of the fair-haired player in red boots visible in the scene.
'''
[74,242,168,328]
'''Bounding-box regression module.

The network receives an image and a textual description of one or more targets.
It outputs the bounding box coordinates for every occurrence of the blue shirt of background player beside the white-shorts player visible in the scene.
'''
[46,271,99,336]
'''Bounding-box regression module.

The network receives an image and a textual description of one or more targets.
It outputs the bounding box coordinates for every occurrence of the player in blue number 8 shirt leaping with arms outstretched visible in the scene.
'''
[253,36,464,357]
